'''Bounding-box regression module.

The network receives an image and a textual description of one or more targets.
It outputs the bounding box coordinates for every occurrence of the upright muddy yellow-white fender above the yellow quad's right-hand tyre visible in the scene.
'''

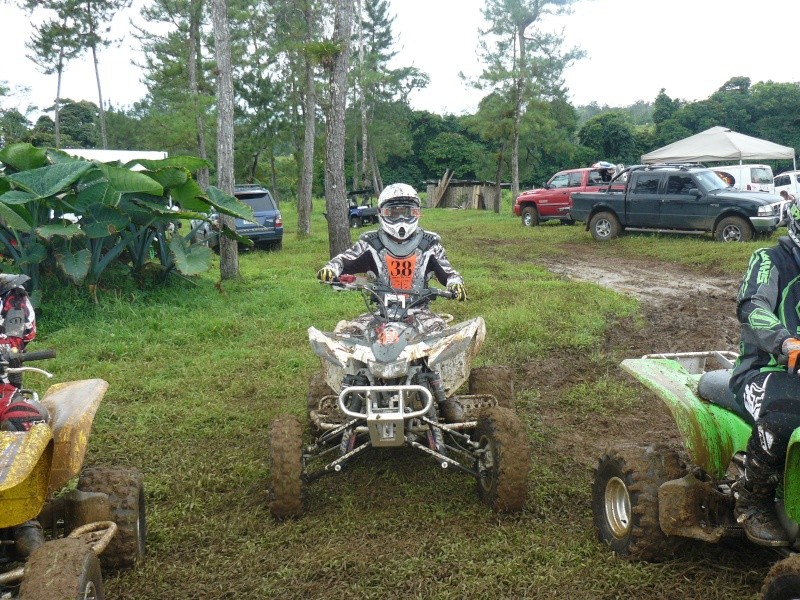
[42,379,108,492]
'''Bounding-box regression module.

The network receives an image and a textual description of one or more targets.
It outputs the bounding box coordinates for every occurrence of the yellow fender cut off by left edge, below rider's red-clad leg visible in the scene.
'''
[0,423,53,529]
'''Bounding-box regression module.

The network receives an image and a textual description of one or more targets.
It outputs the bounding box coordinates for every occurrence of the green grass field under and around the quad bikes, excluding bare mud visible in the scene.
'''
[32,202,770,600]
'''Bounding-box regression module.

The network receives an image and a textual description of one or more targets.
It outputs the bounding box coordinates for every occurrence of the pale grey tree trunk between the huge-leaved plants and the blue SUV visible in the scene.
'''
[211,0,239,280]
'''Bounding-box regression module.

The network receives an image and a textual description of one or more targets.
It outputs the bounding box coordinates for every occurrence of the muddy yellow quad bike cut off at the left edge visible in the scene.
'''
[0,350,145,600]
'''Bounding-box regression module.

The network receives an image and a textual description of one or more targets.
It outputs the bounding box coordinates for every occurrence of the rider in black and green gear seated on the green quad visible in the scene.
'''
[730,196,800,546]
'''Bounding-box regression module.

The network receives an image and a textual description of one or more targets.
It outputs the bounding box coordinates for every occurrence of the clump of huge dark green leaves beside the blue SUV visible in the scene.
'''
[0,144,253,290]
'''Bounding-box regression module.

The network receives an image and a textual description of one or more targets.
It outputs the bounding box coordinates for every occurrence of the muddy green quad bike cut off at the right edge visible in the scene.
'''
[592,351,800,600]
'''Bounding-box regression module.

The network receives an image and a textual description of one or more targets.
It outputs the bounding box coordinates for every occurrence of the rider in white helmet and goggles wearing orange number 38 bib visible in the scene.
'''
[317,183,467,421]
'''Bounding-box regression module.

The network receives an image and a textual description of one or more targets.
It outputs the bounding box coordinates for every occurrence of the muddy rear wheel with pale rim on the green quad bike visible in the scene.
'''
[592,445,685,562]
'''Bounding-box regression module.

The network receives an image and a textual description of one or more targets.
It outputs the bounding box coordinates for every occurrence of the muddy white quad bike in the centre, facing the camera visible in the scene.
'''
[270,276,530,518]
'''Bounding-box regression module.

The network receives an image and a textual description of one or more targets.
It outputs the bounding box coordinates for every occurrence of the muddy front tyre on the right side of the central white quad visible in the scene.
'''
[474,406,531,512]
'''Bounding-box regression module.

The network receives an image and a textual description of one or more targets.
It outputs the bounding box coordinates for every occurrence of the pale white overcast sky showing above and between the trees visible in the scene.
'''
[0,0,800,119]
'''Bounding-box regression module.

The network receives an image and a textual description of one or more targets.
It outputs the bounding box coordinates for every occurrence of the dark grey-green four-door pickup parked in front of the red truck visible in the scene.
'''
[570,165,783,242]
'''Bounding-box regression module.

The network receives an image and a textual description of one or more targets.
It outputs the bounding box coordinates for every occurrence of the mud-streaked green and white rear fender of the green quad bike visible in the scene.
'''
[620,358,752,478]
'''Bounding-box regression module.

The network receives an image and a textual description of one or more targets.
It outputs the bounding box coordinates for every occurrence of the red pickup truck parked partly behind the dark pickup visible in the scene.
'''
[514,167,624,227]
